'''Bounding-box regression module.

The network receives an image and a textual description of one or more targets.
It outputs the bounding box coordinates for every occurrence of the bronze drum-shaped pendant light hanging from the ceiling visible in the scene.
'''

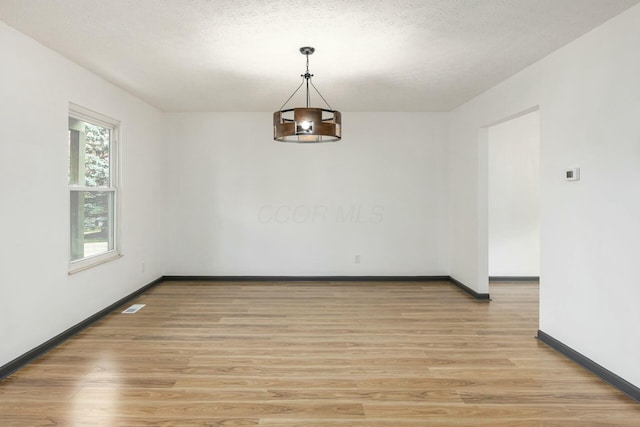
[273,46,342,143]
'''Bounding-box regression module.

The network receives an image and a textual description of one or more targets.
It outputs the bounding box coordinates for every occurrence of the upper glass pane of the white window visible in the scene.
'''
[69,117,111,187]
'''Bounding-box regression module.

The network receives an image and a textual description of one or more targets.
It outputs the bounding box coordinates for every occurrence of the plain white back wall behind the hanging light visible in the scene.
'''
[165,113,448,276]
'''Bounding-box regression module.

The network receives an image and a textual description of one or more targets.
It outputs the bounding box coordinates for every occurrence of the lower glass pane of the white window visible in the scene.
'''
[71,191,114,261]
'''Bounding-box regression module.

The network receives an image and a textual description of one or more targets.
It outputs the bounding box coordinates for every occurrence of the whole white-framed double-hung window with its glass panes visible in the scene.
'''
[69,105,119,272]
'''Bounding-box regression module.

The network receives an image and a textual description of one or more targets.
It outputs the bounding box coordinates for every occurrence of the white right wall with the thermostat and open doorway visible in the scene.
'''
[449,6,640,386]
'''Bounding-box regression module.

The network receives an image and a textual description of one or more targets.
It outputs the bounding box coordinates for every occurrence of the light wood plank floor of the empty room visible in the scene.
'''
[0,282,640,427]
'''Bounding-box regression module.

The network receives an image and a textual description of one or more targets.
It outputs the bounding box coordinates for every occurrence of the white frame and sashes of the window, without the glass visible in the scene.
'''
[67,103,122,274]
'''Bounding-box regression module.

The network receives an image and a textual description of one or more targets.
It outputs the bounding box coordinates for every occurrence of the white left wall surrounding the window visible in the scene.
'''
[0,23,164,366]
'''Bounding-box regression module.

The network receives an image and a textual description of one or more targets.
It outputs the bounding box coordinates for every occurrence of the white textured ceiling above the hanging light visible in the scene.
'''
[0,0,640,111]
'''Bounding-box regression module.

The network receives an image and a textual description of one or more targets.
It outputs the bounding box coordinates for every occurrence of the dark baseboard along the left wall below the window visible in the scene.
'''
[0,277,164,379]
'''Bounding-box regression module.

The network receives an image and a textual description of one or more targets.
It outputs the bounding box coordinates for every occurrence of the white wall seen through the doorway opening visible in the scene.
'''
[488,111,540,277]
